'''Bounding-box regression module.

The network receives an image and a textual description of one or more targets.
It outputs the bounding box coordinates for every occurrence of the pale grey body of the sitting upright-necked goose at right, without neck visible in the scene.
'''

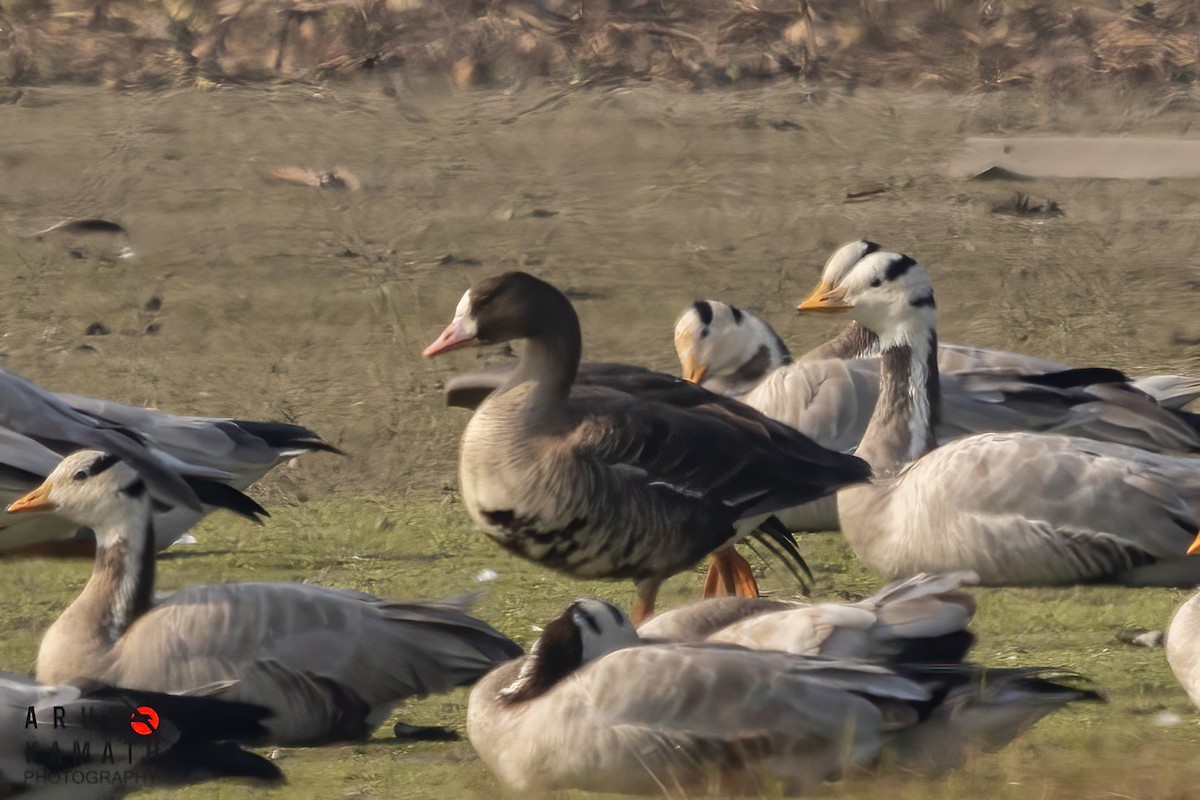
[839,433,1200,585]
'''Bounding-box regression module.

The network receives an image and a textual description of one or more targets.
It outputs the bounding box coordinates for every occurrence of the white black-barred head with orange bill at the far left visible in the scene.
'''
[8,450,151,546]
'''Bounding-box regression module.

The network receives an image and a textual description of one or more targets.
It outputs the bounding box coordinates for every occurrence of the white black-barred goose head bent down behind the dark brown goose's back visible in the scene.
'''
[674,300,792,391]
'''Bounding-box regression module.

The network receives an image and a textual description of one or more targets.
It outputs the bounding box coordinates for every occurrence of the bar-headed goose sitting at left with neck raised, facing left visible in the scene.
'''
[8,450,521,744]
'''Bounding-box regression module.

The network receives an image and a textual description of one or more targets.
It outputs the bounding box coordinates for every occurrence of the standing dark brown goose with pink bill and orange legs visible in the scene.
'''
[425,272,868,621]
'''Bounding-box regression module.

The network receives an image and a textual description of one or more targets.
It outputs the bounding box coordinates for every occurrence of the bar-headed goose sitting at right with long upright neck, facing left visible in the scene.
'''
[799,251,1200,585]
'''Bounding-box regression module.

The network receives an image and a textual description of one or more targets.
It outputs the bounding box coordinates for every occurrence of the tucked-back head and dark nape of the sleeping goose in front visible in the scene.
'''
[500,597,641,703]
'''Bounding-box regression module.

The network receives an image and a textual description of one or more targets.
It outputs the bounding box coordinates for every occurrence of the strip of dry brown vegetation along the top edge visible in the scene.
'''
[0,0,1200,91]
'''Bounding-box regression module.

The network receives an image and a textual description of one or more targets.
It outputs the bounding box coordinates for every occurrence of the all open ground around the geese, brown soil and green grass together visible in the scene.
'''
[0,76,1200,798]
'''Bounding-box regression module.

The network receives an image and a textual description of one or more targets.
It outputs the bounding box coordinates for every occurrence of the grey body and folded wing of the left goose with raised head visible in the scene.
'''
[112,584,521,741]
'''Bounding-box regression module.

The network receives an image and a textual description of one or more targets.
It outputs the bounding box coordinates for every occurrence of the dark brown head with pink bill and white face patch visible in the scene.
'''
[424,272,578,356]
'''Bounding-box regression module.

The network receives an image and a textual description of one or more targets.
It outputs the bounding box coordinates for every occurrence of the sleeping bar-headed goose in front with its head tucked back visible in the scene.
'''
[467,600,1096,795]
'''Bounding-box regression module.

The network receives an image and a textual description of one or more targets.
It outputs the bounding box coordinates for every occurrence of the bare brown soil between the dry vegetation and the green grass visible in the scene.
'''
[0,80,1200,506]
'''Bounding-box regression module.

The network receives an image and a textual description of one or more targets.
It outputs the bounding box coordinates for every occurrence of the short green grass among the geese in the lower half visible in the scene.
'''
[0,493,1200,799]
